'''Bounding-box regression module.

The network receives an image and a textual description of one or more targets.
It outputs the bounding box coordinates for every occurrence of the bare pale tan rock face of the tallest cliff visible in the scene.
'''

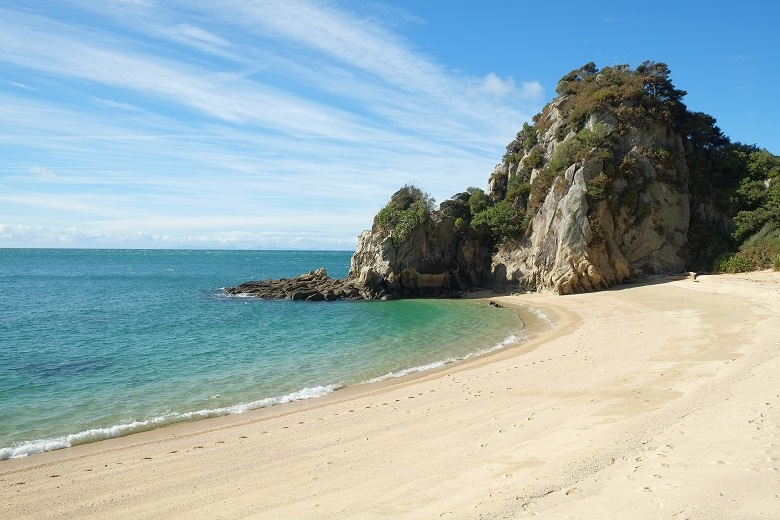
[491,110,690,294]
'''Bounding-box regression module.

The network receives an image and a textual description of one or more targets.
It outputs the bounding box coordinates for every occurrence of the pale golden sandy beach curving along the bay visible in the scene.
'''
[0,272,780,520]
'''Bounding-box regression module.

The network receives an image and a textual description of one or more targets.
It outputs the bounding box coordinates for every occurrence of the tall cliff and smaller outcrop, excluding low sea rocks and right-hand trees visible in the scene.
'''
[349,63,704,296]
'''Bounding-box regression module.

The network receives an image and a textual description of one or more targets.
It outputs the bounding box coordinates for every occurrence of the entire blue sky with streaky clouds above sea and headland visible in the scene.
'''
[0,0,780,250]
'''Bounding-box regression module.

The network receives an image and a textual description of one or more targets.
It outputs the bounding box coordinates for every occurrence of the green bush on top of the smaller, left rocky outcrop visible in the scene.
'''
[374,184,435,246]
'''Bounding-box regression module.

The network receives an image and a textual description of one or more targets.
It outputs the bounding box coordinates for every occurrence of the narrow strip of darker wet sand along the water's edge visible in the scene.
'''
[0,290,556,472]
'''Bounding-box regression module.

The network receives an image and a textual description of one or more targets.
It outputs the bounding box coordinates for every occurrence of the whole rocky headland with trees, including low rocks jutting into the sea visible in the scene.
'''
[226,62,780,301]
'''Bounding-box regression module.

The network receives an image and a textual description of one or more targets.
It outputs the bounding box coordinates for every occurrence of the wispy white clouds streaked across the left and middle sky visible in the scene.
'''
[0,0,543,247]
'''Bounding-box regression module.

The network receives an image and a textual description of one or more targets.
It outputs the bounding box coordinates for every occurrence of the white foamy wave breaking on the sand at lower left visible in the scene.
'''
[0,385,338,460]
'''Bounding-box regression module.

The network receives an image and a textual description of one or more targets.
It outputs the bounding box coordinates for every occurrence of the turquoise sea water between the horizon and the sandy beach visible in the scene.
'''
[0,249,523,460]
